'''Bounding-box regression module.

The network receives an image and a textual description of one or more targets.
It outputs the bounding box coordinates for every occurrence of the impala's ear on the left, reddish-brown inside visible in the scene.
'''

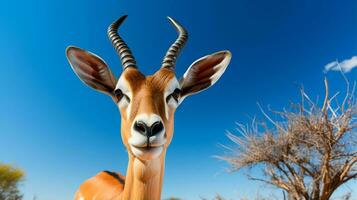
[66,46,117,96]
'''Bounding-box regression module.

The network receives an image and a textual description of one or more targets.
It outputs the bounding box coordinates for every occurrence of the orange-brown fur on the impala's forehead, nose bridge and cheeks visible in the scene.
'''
[119,68,175,148]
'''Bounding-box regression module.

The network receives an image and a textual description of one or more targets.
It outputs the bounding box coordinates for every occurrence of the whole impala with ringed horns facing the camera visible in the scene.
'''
[66,15,231,200]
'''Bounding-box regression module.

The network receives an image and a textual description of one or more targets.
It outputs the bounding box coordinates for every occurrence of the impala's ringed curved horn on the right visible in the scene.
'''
[162,17,188,70]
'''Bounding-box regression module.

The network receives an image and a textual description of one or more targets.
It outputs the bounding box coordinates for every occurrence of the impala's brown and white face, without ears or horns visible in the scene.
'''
[114,68,181,160]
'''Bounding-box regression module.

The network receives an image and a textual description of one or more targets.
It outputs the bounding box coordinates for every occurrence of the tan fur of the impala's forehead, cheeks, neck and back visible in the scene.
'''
[74,68,175,200]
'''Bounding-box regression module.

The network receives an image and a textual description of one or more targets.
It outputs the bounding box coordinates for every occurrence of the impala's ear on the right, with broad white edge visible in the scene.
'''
[180,51,232,98]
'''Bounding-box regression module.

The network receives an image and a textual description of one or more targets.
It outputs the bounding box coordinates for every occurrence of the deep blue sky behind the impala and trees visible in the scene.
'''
[0,0,357,200]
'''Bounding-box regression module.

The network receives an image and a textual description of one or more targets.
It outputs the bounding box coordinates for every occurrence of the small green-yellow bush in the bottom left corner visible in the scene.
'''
[0,163,24,200]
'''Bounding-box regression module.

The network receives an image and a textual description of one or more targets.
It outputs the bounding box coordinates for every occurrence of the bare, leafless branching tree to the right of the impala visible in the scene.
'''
[221,80,357,200]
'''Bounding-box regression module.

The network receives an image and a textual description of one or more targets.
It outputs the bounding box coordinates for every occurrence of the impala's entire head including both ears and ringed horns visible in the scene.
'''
[66,16,231,160]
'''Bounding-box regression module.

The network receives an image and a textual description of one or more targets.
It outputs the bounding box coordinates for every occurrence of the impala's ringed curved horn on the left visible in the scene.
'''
[108,15,137,70]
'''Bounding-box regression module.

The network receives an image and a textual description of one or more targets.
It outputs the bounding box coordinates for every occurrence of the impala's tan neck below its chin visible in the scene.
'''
[121,151,166,200]
